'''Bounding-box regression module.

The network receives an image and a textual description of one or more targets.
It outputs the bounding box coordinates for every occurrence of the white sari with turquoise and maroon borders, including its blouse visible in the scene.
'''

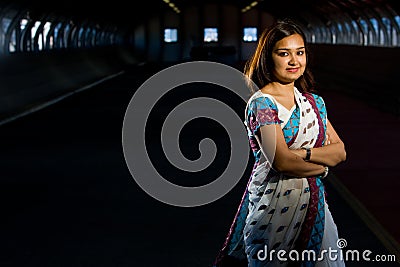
[214,88,345,267]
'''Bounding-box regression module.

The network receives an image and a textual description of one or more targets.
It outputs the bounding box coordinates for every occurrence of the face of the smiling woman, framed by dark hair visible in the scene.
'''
[272,34,307,84]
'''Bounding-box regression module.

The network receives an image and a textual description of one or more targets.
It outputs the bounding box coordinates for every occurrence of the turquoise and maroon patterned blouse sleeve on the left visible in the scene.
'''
[247,96,282,134]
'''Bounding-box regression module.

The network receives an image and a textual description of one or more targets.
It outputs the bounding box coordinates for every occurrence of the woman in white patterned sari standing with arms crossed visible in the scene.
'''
[214,21,346,267]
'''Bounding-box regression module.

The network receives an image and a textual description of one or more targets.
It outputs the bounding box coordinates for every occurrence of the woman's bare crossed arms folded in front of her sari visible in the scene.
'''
[260,121,346,177]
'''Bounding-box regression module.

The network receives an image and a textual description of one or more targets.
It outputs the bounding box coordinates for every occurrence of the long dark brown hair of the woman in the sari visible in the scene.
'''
[244,19,315,93]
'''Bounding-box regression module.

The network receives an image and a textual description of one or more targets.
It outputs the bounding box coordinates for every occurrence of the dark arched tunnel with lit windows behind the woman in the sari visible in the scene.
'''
[0,0,400,267]
